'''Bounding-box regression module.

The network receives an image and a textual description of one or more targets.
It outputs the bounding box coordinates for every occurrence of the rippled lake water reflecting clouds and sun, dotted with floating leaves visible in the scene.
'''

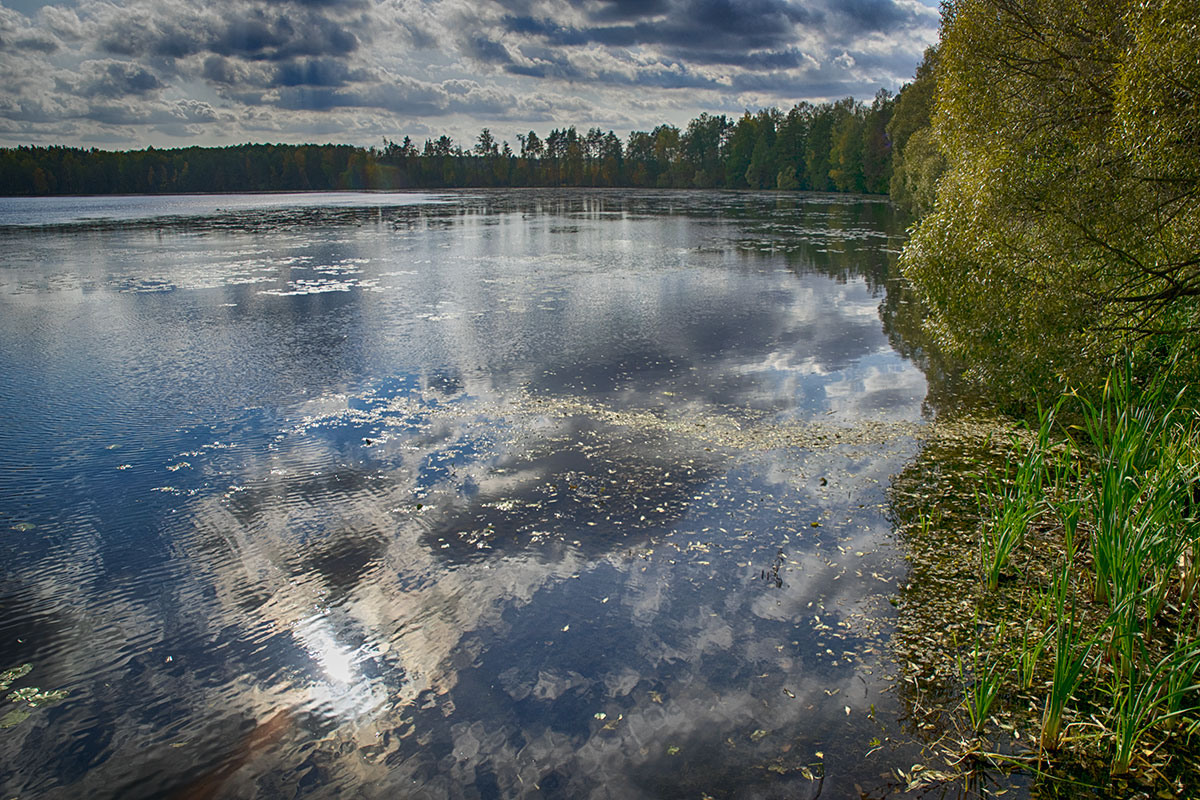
[0,192,928,799]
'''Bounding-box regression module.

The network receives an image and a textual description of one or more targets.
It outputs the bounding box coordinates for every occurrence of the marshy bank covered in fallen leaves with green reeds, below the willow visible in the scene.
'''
[892,368,1200,798]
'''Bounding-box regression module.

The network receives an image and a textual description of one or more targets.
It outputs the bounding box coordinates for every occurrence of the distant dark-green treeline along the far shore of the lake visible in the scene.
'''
[0,88,907,196]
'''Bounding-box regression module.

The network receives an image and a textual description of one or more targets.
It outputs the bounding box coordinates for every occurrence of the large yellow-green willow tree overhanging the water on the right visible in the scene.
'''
[902,0,1200,397]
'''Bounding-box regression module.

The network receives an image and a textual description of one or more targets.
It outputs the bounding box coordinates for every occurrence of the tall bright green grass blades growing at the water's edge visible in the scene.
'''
[960,362,1200,776]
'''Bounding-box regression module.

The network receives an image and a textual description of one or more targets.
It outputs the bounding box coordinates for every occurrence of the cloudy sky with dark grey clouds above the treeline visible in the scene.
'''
[0,0,938,149]
